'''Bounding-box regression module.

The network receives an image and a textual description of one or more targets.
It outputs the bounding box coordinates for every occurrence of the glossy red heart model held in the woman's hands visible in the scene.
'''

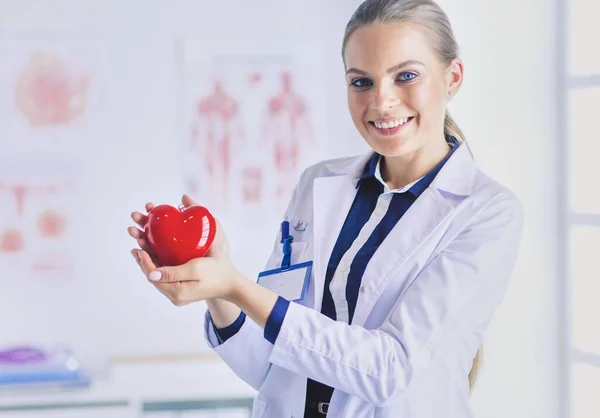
[144,205,217,266]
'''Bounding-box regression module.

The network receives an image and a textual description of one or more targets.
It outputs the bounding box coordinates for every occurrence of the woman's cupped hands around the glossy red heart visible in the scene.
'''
[128,195,242,306]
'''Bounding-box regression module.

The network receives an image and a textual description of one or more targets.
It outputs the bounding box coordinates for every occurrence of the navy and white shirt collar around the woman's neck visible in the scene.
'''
[356,135,459,197]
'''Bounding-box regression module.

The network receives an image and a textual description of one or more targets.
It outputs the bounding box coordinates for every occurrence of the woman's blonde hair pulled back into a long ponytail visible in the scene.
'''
[342,0,483,390]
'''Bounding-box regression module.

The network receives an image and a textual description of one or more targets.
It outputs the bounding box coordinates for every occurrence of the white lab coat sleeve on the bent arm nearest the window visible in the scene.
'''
[270,194,523,406]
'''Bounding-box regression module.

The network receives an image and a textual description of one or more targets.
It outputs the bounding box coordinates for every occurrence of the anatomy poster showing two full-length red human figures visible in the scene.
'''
[180,39,326,232]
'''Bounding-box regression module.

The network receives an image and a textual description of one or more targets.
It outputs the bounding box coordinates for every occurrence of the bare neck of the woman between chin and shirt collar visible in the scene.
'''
[381,138,450,190]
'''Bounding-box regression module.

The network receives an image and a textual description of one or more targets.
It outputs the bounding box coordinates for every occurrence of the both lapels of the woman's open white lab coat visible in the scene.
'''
[313,143,476,325]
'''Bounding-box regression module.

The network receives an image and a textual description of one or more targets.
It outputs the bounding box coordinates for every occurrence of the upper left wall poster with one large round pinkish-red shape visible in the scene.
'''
[0,35,103,155]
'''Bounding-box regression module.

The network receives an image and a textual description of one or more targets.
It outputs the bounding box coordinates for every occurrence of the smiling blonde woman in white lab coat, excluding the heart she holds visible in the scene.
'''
[130,0,522,418]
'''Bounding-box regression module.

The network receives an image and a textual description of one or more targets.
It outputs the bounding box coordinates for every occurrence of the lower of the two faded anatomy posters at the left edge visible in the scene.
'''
[0,161,78,279]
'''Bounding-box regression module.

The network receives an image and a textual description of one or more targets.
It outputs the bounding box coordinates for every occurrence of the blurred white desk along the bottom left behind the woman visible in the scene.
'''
[0,359,256,418]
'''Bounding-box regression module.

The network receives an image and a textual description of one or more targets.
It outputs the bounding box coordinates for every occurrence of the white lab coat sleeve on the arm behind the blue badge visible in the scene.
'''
[204,167,306,390]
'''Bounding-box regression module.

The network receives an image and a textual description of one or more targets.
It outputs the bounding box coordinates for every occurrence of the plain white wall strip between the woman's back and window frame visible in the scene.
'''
[446,0,560,418]
